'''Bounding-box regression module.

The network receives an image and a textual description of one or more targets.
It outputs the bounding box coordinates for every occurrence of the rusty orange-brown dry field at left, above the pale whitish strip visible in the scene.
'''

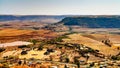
[0,28,59,43]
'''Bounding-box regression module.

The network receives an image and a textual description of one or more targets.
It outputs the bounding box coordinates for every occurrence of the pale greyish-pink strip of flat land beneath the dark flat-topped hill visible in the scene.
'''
[70,26,120,34]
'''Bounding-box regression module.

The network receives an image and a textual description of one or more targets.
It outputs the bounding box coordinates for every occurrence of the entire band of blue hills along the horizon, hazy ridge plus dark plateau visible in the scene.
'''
[0,15,120,28]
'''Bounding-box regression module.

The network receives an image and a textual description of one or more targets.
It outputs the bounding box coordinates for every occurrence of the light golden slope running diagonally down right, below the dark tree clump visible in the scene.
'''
[64,34,118,55]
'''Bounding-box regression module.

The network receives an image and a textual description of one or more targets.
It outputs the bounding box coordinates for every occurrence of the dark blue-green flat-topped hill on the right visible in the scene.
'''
[58,16,120,28]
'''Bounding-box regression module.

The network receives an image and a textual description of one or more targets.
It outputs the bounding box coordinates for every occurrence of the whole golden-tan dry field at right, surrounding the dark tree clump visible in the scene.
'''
[63,34,120,55]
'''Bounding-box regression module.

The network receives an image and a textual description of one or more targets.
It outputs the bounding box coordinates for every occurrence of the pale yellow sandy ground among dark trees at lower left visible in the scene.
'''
[1,49,61,59]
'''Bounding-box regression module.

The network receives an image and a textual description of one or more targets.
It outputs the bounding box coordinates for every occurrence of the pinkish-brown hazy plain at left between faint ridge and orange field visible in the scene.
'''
[0,21,47,29]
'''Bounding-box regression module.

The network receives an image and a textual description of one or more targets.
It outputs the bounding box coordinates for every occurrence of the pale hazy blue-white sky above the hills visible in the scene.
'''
[0,0,120,15]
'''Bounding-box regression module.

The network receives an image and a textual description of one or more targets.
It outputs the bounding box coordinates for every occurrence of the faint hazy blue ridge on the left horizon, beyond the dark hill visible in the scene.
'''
[0,15,65,23]
